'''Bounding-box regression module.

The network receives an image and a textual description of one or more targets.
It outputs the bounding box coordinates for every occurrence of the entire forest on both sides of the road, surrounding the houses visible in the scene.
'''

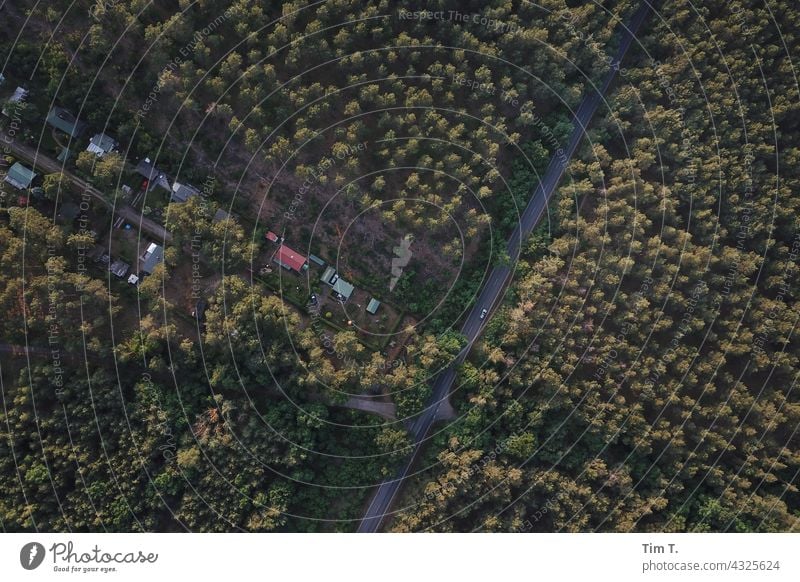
[0,0,800,532]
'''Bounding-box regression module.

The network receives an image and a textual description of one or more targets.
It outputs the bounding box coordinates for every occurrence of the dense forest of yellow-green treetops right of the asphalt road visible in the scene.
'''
[392,2,800,532]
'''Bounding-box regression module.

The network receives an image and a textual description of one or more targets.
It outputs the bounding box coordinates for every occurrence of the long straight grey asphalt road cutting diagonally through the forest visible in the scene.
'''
[358,0,655,533]
